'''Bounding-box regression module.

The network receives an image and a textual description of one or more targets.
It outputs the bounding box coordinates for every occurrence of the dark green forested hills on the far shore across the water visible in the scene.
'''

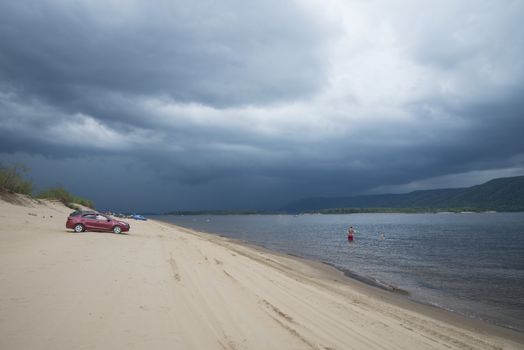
[281,176,524,213]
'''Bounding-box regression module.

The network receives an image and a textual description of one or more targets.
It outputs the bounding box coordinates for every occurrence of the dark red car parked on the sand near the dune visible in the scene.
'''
[66,212,129,233]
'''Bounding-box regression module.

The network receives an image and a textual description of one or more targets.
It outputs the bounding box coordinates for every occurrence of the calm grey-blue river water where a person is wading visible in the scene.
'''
[157,213,524,331]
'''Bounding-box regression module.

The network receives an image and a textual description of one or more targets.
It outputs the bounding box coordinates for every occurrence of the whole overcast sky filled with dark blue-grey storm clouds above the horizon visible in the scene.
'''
[0,0,524,211]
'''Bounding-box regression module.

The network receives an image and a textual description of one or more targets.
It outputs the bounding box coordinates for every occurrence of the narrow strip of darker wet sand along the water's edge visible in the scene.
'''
[159,219,524,347]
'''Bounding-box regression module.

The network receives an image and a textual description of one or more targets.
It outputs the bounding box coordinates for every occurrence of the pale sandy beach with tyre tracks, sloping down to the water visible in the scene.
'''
[0,197,524,350]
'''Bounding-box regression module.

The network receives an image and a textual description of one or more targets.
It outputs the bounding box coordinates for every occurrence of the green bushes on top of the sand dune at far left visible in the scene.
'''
[0,164,95,209]
